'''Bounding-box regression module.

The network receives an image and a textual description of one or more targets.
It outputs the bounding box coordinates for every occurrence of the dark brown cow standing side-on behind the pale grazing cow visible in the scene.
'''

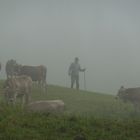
[18,65,47,90]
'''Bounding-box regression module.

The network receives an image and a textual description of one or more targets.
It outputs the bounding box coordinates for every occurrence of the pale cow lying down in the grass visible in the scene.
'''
[27,100,65,113]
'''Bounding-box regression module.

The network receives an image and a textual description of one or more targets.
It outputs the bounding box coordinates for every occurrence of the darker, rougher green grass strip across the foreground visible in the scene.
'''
[0,104,140,140]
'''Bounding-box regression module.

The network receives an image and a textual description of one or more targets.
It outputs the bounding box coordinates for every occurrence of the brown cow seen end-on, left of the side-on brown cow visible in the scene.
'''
[5,59,18,78]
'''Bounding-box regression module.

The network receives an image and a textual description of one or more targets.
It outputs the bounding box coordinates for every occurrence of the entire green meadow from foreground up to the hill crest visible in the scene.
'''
[0,81,140,140]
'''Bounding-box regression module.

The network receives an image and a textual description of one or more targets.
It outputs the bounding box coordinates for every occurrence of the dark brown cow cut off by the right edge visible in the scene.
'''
[117,86,140,109]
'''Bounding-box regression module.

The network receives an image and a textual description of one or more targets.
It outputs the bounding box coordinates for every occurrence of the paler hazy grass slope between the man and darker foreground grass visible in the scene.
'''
[32,86,134,117]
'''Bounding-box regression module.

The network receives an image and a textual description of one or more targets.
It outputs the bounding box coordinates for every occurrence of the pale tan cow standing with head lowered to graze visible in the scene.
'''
[4,75,32,105]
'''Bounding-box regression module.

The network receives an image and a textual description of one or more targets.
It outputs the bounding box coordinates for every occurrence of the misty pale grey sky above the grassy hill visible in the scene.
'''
[0,0,140,94]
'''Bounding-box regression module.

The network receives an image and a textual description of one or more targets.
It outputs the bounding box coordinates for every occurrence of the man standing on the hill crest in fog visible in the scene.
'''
[68,57,86,90]
